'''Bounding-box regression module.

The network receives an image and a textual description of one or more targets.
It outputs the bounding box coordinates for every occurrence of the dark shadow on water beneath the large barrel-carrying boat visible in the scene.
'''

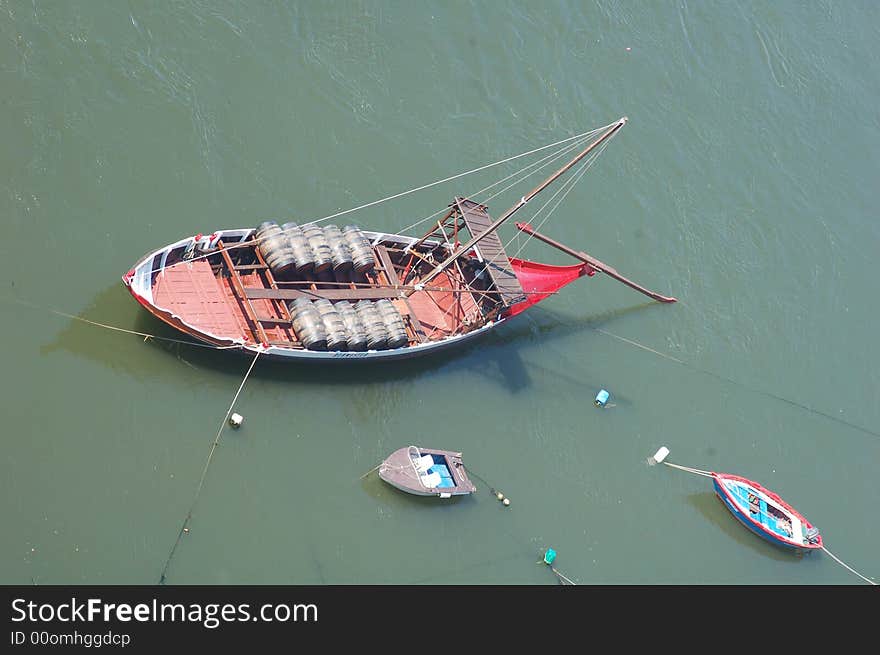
[40,284,656,402]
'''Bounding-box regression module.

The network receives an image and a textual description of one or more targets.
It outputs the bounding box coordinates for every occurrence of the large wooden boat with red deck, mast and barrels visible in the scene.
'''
[122,118,675,361]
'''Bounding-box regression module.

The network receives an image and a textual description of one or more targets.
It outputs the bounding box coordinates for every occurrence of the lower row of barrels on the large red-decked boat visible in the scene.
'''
[288,297,409,351]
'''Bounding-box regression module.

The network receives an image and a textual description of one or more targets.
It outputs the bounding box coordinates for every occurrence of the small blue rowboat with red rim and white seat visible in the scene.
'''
[711,472,822,551]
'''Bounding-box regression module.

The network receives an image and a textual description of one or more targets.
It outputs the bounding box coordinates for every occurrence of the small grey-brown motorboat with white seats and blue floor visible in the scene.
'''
[379,446,477,498]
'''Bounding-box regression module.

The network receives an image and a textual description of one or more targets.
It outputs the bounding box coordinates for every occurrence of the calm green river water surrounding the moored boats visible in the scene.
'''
[0,0,880,585]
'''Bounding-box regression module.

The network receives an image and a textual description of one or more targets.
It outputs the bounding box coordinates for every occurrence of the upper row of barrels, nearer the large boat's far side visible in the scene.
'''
[254,221,374,279]
